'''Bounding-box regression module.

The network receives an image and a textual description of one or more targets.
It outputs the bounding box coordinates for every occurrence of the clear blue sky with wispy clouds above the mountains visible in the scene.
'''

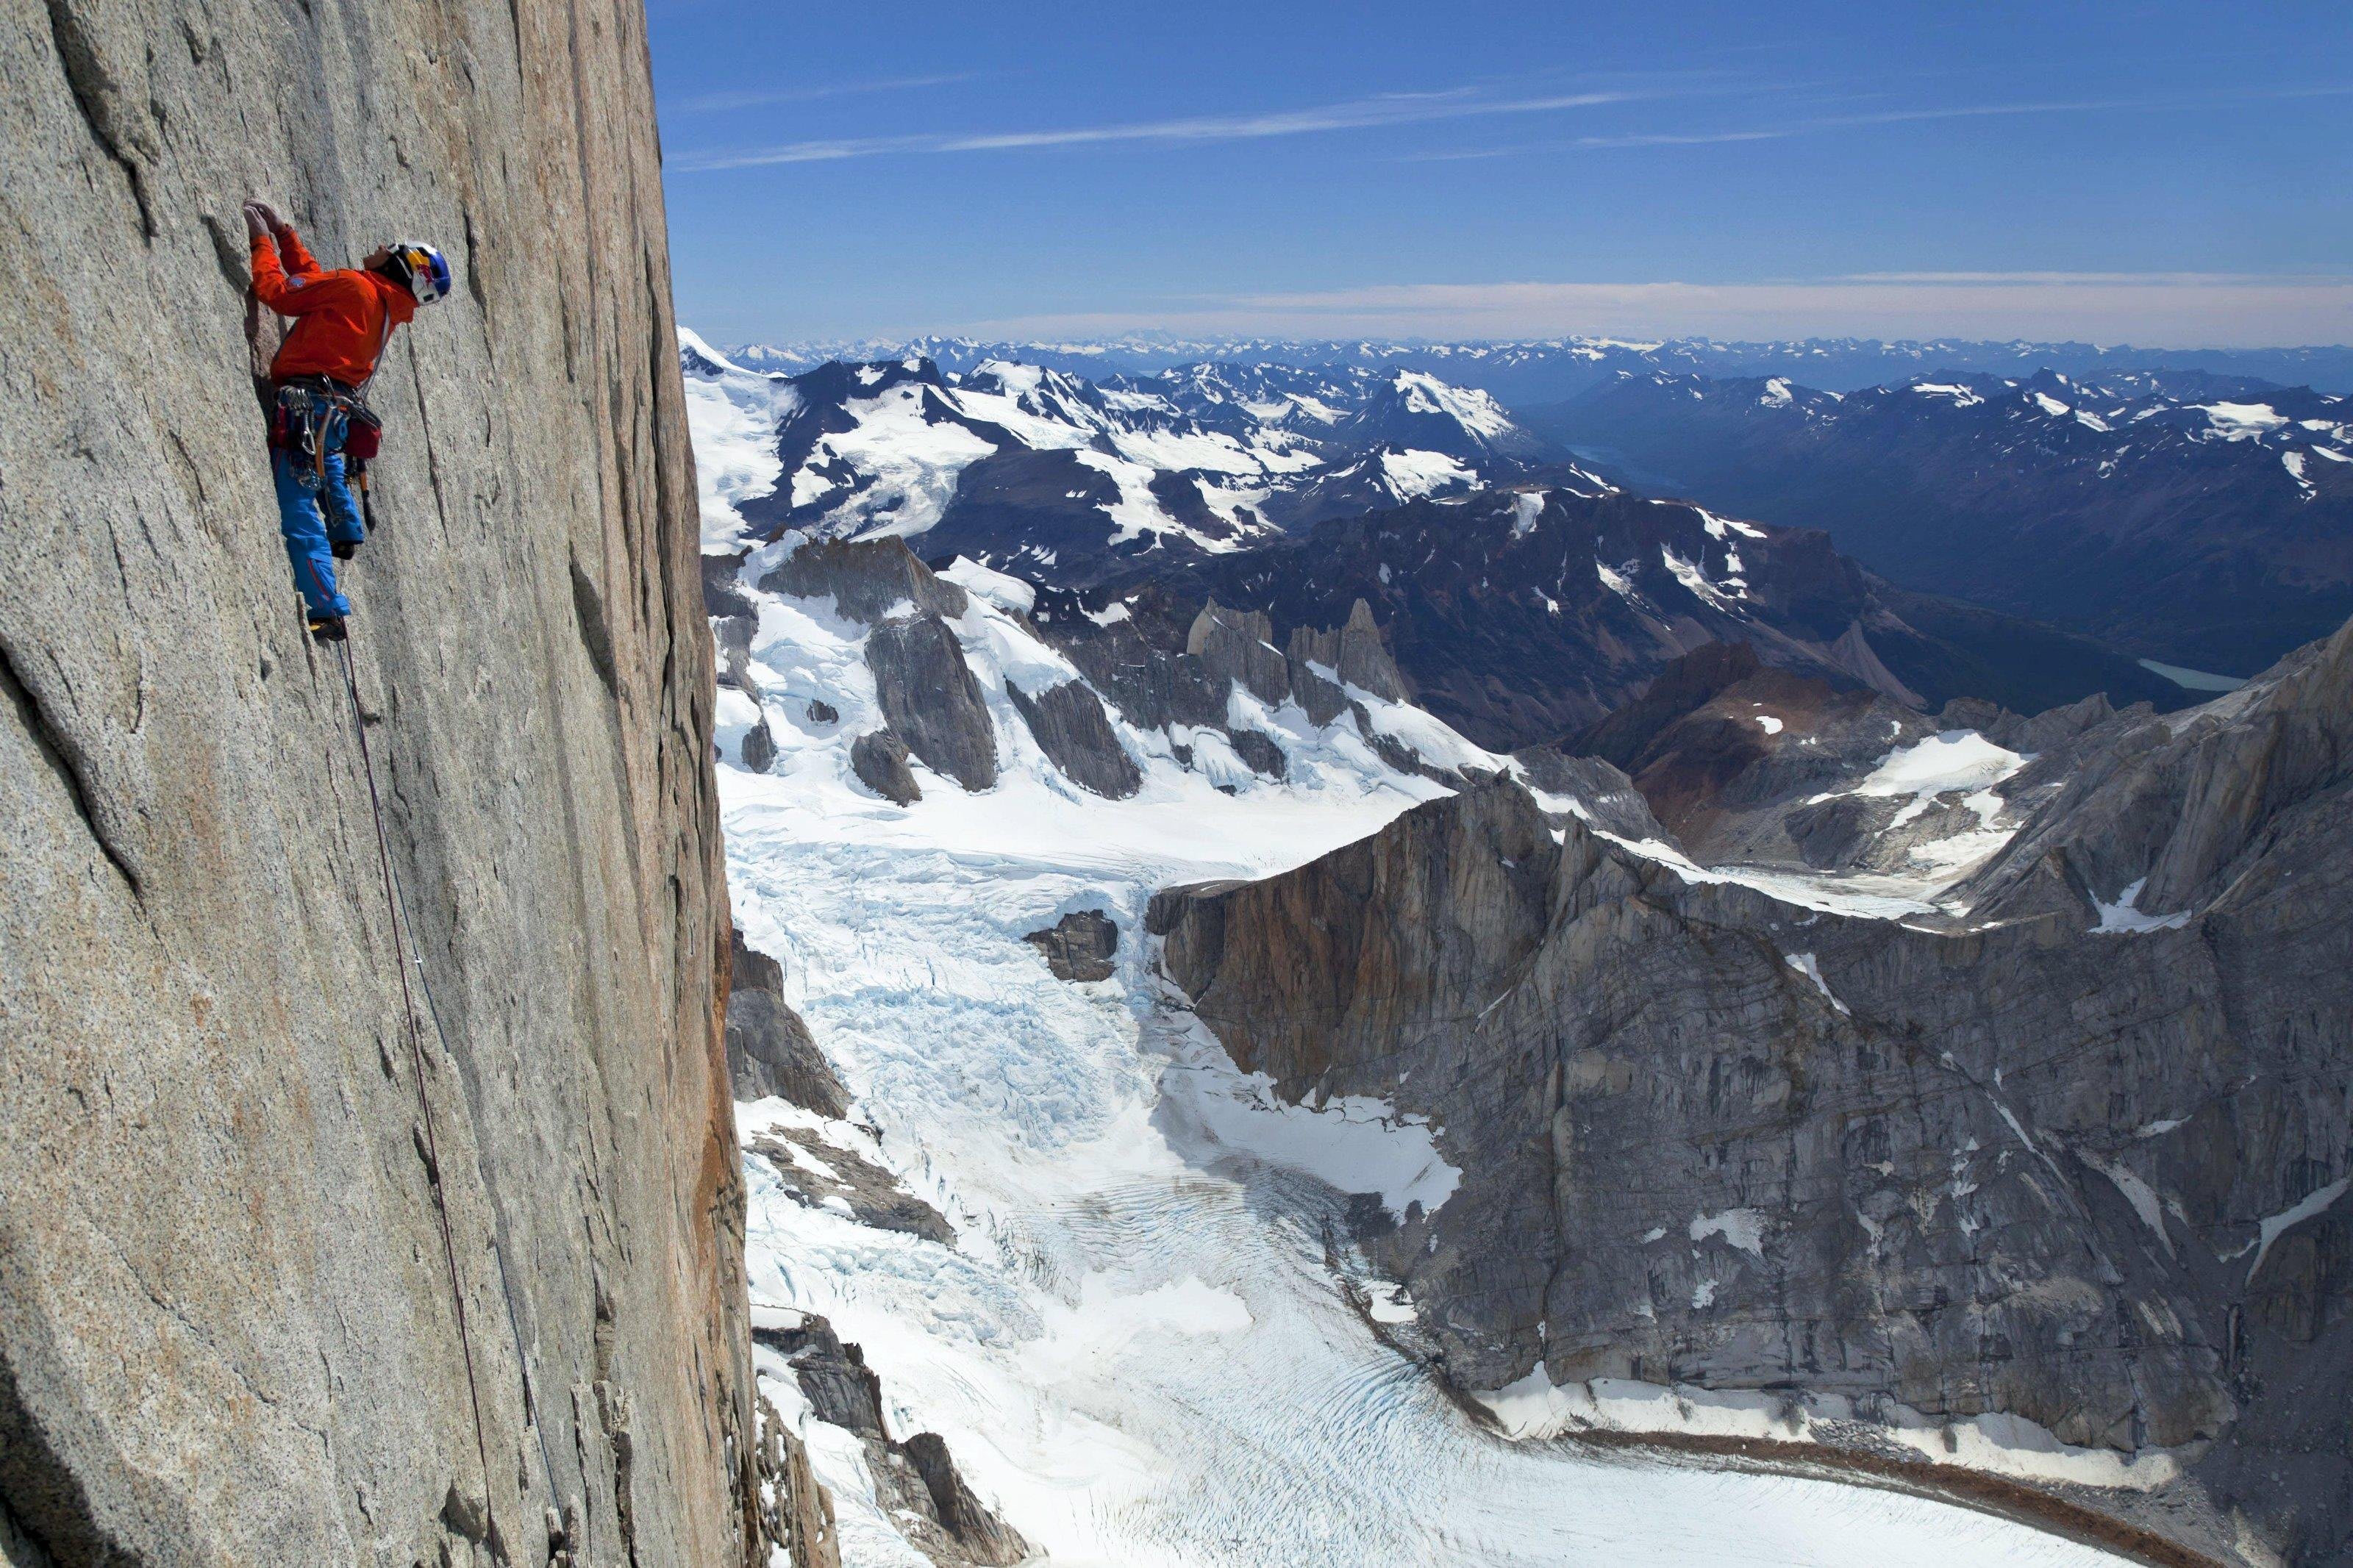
[647,0,2353,346]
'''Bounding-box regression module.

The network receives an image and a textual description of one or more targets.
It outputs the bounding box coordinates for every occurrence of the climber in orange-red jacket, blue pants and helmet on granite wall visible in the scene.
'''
[245,202,449,642]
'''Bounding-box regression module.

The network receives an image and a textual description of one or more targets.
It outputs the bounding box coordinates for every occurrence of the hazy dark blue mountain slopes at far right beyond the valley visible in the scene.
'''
[1522,371,2353,675]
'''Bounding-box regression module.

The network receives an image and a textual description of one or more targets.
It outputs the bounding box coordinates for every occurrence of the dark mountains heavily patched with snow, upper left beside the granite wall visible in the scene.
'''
[680,334,1607,585]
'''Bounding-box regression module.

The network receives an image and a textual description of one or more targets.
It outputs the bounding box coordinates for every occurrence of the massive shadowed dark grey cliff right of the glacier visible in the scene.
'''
[1153,628,2353,1561]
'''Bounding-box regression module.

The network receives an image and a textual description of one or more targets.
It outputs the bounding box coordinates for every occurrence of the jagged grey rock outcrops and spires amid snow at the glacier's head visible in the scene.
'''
[704,534,1508,804]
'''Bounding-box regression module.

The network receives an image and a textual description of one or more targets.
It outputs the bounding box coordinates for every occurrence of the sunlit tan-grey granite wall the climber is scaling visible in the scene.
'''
[0,0,781,1568]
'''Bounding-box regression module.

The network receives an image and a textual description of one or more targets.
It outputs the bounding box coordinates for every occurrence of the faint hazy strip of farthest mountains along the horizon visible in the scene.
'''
[729,336,2353,409]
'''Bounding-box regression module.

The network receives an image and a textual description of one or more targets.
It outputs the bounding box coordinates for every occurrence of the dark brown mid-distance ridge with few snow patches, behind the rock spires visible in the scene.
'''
[1043,479,2184,750]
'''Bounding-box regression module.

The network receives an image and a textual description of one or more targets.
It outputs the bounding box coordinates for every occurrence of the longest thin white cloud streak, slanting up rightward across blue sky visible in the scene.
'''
[678,87,1654,169]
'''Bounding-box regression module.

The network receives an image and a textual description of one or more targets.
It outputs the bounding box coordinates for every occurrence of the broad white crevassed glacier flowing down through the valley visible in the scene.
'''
[720,557,2113,1568]
